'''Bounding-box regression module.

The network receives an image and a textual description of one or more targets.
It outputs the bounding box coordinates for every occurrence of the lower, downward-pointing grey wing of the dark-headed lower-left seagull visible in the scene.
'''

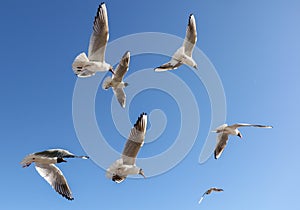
[35,163,74,200]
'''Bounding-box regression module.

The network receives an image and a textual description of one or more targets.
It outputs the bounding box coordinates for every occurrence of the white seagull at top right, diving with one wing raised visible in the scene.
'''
[154,14,197,71]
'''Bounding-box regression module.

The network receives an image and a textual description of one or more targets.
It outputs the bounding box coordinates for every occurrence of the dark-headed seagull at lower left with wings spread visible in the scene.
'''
[20,149,89,200]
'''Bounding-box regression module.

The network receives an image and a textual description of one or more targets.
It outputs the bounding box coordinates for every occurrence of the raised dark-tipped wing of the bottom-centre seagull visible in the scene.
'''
[122,113,147,165]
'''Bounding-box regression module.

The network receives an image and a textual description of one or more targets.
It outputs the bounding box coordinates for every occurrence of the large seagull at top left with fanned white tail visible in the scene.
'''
[72,3,114,77]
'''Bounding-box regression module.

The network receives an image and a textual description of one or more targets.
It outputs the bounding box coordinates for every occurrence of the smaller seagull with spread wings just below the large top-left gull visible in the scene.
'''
[102,51,130,108]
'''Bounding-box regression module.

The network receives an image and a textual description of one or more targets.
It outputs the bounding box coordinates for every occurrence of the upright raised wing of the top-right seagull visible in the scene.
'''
[183,14,197,57]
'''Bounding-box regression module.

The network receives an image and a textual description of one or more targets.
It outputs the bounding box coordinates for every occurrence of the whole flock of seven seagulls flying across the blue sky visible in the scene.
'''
[20,3,272,203]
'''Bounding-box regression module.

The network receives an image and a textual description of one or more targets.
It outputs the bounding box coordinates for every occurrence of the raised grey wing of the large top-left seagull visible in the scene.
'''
[88,3,109,62]
